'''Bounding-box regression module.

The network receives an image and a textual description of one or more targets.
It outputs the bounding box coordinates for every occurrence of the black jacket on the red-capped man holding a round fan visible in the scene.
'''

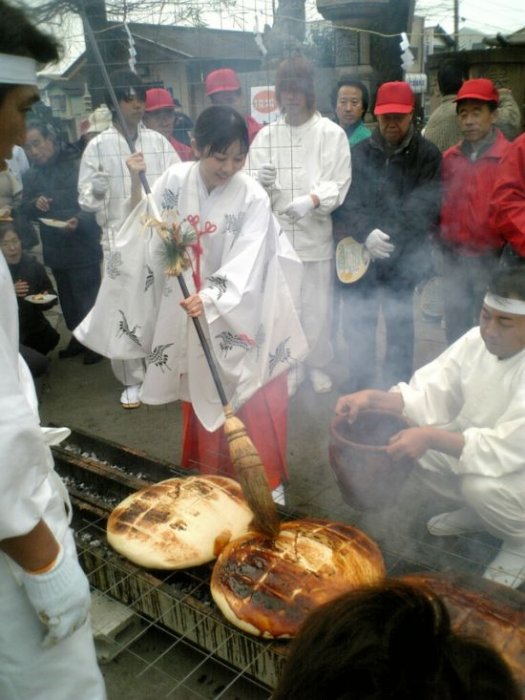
[333,131,441,287]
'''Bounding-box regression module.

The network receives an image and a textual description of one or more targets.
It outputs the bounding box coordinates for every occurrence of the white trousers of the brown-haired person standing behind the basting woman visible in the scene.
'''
[300,260,333,368]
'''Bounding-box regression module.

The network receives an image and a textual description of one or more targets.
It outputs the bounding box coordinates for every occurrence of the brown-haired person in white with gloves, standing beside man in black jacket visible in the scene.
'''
[247,58,351,395]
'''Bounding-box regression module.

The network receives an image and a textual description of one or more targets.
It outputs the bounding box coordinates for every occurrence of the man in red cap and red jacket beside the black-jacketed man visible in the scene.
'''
[439,78,510,345]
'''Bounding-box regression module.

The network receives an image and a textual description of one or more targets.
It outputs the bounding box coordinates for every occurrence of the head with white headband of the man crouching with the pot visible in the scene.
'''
[479,264,525,360]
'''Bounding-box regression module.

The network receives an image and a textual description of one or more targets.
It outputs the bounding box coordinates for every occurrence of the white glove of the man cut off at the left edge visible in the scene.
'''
[22,547,91,647]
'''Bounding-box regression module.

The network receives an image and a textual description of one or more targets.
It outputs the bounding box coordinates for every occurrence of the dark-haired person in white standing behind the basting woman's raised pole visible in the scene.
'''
[78,70,180,408]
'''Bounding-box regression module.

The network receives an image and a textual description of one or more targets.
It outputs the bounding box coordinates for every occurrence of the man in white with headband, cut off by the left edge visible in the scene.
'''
[0,0,106,700]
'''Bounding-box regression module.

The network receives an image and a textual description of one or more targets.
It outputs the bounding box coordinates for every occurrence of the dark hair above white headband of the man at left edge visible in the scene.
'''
[0,0,61,105]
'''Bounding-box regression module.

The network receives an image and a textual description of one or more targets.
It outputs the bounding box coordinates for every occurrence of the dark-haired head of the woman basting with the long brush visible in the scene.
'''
[191,105,249,192]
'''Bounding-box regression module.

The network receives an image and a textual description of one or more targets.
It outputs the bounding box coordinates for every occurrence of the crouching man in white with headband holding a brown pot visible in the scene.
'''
[336,266,525,588]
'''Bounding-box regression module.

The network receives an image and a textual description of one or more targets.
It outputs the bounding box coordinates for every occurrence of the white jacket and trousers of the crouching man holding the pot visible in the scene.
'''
[396,328,525,543]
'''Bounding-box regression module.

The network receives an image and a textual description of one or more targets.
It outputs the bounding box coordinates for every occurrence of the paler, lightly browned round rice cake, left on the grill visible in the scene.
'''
[107,476,253,569]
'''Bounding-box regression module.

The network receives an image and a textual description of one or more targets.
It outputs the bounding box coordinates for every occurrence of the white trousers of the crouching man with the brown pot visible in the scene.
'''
[419,450,525,546]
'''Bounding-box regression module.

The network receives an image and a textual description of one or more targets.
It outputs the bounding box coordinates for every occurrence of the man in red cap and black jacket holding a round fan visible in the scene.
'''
[334,81,441,392]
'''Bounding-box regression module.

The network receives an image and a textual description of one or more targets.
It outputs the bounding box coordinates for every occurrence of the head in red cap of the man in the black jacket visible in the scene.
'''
[374,80,416,146]
